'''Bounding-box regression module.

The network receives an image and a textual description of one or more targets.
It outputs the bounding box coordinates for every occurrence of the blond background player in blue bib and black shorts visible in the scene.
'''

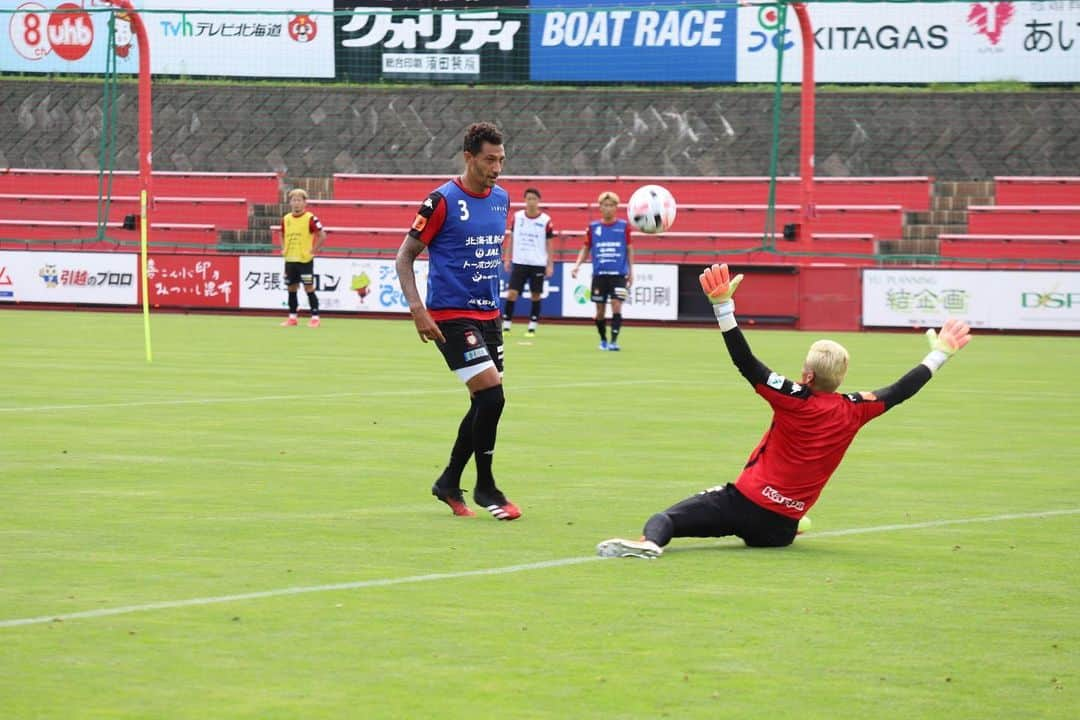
[570,191,634,351]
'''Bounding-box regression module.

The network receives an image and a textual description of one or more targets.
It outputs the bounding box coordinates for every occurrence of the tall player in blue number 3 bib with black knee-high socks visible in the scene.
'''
[396,123,522,520]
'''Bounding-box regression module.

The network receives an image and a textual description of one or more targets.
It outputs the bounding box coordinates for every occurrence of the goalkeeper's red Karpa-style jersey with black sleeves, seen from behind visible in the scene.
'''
[724,327,931,519]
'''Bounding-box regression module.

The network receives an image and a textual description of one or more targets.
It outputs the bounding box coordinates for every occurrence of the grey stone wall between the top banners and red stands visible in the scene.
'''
[0,80,1080,179]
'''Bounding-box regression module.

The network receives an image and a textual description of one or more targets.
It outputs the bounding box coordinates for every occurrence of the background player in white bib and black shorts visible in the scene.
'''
[502,188,555,338]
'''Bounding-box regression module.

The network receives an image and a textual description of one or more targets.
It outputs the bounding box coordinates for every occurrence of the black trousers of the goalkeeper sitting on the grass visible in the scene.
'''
[664,483,799,547]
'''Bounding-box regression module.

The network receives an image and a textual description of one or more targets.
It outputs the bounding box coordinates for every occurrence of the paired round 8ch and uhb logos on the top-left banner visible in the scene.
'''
[8,2,94,60]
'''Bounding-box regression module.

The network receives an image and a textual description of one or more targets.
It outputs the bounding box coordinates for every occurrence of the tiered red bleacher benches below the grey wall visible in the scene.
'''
[8,168,1080,264]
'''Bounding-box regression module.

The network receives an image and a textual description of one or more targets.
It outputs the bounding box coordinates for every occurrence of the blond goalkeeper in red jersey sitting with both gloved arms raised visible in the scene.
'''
[596,264,971,558]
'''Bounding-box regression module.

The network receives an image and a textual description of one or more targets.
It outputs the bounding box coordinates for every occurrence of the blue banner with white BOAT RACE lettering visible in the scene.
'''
[529,0,738,83]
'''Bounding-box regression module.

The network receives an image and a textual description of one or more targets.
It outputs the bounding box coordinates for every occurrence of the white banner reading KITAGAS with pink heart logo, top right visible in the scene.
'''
[739,1,1080,83]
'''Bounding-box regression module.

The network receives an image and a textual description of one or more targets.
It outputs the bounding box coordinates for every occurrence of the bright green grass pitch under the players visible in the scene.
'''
[0,311,1080,720]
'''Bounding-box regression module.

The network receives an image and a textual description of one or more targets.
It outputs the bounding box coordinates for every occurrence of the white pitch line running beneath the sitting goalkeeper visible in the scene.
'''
[0,507,1080,627]
